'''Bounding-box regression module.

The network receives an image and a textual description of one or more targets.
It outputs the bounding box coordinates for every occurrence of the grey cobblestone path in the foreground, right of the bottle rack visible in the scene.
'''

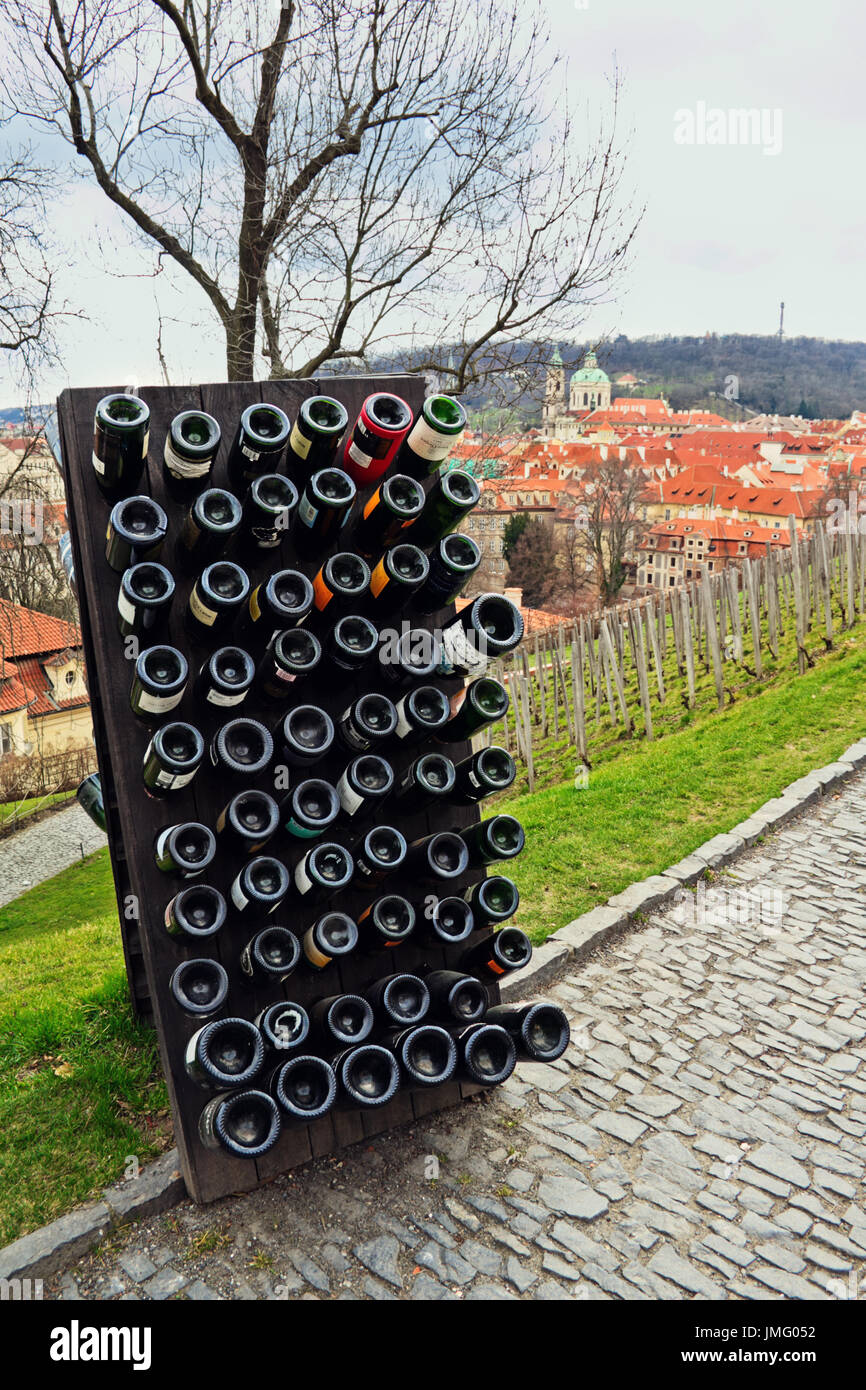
[46,774,866,1300]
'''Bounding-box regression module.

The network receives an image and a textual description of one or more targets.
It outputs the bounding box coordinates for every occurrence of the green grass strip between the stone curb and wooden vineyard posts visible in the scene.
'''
[505,630,866,942]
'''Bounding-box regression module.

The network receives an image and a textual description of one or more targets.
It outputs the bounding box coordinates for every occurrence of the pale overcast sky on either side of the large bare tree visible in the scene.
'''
[0,0,866,406]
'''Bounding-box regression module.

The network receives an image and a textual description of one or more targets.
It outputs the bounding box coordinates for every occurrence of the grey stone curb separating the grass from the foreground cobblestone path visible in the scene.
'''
[0,738,866,1279]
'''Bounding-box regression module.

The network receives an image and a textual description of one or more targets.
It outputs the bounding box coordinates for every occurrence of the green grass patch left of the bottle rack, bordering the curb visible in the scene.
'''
[0,849,168,1244]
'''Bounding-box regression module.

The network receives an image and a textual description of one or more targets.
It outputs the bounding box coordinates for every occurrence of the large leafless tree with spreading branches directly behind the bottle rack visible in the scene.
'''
[0,0,634,386]
